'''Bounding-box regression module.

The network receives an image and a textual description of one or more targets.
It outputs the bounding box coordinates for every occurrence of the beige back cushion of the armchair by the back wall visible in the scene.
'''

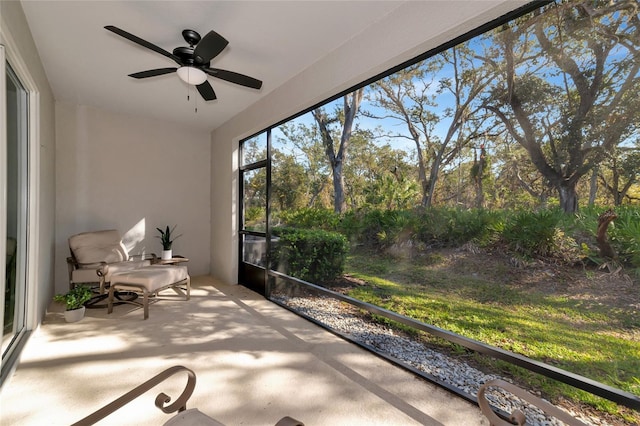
[69,229,129,263]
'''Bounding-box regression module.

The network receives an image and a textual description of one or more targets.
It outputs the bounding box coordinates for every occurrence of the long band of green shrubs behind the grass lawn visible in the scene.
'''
[280,207,640,268]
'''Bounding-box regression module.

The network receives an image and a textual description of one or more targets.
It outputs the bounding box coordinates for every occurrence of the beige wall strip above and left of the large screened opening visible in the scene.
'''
[211,0,527,283]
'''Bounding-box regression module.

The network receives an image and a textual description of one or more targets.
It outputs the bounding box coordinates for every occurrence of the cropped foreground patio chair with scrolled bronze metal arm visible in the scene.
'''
[71,365,304,426]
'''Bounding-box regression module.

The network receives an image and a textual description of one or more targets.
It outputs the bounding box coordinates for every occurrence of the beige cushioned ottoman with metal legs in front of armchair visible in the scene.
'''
[107,265,191,319]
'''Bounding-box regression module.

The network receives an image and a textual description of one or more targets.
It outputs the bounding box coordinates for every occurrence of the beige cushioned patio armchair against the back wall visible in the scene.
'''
[67,229,156,295]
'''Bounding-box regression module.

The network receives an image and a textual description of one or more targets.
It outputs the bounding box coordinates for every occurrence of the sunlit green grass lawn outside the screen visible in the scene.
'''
[345,252,640,423]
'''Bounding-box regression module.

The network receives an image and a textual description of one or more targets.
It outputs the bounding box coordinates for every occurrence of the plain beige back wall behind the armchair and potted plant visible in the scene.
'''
[55,103,211,291]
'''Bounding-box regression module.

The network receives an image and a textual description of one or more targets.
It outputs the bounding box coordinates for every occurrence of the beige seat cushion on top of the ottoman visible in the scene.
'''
[111,265,189,292]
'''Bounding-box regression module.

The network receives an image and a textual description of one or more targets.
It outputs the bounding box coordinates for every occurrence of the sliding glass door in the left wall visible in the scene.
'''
[0,63,29,365]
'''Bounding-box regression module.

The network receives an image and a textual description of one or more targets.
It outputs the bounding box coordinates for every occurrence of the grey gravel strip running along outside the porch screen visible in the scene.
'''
[272,295,609,426]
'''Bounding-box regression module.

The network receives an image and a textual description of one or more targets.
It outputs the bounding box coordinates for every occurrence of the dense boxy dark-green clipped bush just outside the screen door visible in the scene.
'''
[273,228,349,284]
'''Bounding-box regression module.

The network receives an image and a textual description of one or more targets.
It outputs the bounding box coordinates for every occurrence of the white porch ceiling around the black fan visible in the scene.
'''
[22,0,524,130]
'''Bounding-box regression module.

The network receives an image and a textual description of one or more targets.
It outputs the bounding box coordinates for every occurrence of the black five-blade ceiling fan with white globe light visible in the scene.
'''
[104,25,262,101]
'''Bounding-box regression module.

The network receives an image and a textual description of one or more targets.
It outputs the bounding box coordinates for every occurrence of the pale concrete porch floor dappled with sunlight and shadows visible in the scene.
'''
[0,277,488,426]
